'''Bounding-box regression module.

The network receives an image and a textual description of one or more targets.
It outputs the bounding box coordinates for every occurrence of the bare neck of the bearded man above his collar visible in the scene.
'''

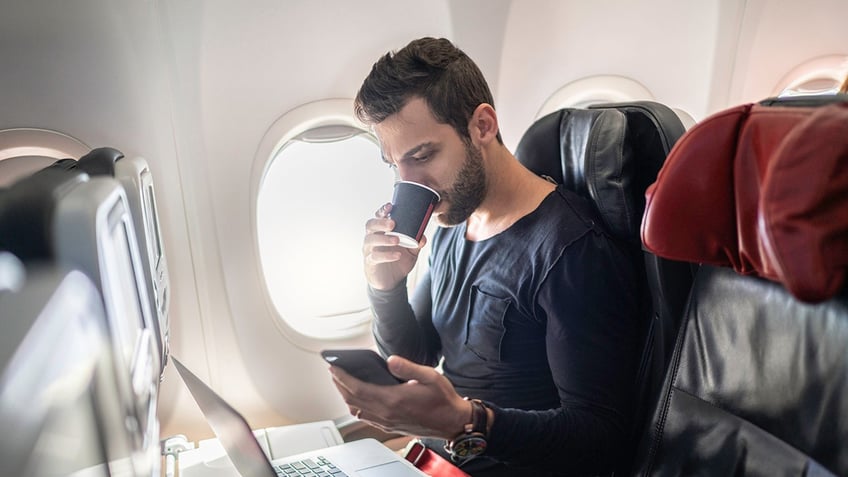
[465,148,556,242]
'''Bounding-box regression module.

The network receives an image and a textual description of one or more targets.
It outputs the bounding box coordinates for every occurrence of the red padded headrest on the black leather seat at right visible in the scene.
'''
[642,102,848,302]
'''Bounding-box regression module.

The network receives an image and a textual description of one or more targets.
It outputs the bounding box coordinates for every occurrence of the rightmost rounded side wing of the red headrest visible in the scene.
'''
[759,103,848,302]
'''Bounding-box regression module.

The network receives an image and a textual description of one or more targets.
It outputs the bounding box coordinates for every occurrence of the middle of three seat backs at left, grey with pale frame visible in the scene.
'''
[53,177,161,458]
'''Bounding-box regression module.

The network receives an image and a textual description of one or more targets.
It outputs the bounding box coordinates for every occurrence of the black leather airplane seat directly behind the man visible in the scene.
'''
[515,101,693,470]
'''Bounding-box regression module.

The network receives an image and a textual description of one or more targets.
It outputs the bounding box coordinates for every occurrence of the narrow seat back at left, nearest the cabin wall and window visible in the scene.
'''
[76,147,170,380]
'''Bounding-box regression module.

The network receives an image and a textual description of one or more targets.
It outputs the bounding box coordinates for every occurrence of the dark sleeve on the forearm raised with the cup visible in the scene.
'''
[368,272,441,366]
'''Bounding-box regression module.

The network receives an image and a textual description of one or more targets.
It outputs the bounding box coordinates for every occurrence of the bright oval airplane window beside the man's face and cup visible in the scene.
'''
[256,125,395,338]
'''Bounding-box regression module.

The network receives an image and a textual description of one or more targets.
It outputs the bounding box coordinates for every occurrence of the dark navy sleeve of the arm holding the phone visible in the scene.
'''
[480,232,641,474]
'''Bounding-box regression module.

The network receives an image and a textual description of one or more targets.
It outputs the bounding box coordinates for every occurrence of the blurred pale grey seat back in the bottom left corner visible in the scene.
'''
[0,251,155,477]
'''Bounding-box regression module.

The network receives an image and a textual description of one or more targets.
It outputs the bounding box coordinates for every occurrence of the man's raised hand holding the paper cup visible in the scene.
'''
[362,204,427,290]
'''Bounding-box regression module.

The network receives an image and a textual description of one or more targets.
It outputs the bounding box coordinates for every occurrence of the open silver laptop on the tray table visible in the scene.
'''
[171,355,426,477]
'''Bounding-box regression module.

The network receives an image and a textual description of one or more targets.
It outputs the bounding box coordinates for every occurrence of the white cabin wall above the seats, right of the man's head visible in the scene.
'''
[496,0,848,151]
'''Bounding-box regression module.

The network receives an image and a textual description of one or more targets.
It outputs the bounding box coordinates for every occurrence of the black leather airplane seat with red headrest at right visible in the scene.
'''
[634,96,848,476]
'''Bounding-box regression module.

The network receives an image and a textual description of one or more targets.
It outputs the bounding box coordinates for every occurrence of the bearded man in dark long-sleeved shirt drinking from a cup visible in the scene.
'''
[331,38,638,476]
